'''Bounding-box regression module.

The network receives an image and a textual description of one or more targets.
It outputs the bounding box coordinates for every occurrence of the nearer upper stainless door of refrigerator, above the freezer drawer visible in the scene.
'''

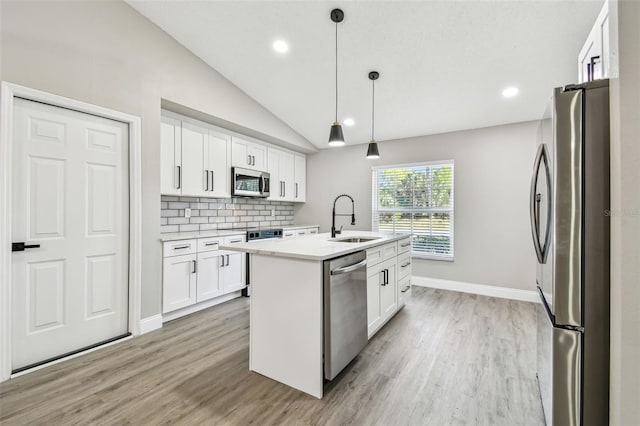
[551,88,584,327]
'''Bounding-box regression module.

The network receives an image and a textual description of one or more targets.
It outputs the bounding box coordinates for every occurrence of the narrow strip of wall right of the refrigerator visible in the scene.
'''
[609,0,640,426]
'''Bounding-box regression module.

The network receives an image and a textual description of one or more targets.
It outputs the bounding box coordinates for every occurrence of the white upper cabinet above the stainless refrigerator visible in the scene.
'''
[578,2,612,83]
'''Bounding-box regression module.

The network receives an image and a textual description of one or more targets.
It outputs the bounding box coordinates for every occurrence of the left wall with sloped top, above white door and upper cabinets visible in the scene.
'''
[0,0,314,317]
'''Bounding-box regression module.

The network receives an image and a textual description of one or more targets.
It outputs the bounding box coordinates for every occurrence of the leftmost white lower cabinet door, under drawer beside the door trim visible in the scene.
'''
[162,254,196,313]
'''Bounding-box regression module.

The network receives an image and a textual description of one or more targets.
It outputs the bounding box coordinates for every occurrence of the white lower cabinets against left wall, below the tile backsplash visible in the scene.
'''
[162,235,246,317]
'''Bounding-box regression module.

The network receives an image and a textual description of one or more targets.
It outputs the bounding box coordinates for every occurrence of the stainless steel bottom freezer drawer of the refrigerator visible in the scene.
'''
[536,295,582,426]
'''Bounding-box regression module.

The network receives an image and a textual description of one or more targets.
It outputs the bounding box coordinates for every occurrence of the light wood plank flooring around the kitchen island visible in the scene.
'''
[0,287,544,426]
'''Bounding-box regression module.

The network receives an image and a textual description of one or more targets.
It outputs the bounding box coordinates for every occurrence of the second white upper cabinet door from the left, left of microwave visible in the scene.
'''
[182,121,209,197]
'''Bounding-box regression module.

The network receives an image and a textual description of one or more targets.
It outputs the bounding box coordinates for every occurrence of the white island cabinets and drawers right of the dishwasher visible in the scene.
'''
[367,238,411,338]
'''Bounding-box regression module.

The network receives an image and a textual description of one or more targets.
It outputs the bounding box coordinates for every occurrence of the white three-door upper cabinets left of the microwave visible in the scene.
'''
[160,114,231,198]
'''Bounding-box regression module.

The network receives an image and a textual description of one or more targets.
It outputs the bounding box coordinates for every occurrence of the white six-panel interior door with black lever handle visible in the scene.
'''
[11,98,129,371]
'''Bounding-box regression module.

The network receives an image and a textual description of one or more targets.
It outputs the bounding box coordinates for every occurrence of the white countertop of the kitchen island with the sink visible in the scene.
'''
[220,231,410,260]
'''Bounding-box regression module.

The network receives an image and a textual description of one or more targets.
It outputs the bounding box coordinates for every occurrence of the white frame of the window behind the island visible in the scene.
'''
[371,159,456,262]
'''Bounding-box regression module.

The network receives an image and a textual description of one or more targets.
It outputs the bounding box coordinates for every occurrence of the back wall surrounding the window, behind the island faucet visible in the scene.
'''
[296,121,540,290]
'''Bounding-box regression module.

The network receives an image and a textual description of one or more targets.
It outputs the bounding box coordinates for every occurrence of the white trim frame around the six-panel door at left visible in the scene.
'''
[0,81,142,382]
